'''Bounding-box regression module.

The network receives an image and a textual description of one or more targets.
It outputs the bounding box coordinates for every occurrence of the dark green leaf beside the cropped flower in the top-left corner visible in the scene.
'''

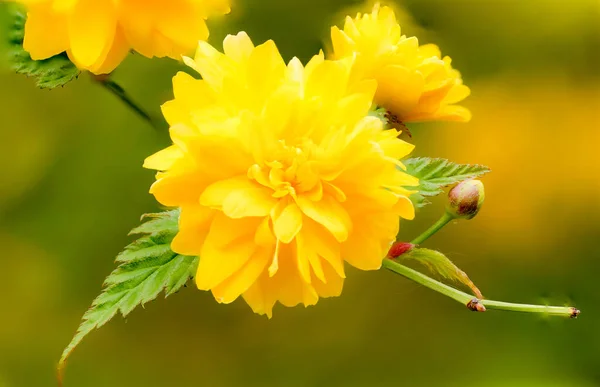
[7,4,80,89]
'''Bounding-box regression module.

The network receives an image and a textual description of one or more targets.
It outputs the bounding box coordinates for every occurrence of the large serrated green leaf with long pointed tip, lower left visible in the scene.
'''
[59,210,198,376]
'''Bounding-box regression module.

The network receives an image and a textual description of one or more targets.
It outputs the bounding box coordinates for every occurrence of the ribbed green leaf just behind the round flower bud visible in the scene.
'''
[402,157,490,207]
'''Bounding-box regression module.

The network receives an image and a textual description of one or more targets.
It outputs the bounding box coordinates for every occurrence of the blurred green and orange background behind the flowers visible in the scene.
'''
[0,0,600,387]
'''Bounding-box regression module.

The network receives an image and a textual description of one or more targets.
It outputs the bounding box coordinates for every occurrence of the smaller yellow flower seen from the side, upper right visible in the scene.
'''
[331,4,471,122]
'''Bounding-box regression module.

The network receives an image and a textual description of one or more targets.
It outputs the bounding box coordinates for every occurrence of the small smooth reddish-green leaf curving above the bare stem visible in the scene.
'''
[398,248,483,299]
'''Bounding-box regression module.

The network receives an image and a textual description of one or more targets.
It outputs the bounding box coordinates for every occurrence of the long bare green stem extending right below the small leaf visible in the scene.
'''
[383,259,579,317]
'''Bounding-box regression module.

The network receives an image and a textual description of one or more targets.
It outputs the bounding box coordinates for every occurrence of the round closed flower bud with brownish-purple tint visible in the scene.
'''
[446,180,485,219]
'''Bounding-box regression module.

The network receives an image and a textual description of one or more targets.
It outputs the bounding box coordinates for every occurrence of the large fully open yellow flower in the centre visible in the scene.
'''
[144,32,416,317]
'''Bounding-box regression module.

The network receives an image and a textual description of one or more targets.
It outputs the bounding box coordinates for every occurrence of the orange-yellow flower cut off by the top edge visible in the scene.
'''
[16,0,229,74]
